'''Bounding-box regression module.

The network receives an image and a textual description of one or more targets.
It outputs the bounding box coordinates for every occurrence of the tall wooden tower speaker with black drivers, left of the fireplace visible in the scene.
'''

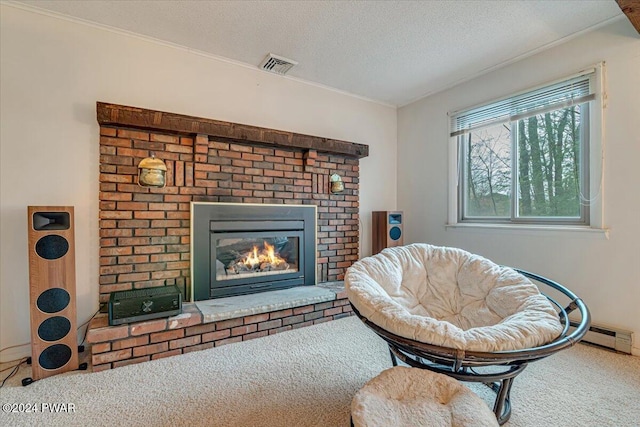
[23,206,78,384]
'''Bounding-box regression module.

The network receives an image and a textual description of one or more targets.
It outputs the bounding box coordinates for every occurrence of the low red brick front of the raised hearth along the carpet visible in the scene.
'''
[86,288,353,372]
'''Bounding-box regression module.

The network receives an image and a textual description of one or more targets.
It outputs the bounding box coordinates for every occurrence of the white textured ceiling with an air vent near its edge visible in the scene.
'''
[13,0,622,105]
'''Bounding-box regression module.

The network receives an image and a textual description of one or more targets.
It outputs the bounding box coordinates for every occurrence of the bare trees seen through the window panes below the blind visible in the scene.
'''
[460,104,588,222]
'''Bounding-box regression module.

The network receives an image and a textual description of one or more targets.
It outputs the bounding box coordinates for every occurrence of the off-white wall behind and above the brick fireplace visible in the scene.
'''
[0,4,397,360]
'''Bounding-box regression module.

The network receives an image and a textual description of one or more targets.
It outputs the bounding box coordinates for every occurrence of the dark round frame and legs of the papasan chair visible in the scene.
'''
[352,269,591,425]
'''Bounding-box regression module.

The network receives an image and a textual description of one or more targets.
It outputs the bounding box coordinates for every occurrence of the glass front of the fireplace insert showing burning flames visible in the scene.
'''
[215,236,300,281]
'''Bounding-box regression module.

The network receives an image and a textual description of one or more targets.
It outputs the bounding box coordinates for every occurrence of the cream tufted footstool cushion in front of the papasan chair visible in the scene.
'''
[351,366,498,427]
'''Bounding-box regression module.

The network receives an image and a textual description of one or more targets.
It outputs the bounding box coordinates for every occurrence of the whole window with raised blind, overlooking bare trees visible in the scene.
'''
[450,69,600,226]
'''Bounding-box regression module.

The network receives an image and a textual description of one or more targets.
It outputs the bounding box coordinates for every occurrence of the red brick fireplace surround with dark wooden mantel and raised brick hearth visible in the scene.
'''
[87,102,368,370]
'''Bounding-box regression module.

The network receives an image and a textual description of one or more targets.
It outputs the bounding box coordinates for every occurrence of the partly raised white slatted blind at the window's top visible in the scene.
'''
[450,70,595,136]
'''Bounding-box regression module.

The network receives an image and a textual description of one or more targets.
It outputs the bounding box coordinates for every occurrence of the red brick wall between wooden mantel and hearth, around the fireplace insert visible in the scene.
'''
[100,126,359,302]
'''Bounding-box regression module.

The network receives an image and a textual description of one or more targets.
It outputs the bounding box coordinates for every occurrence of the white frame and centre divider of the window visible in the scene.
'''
[447,62,606,230]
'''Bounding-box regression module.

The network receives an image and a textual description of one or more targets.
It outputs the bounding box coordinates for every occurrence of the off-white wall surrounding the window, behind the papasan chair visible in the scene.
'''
[398,19,640,354]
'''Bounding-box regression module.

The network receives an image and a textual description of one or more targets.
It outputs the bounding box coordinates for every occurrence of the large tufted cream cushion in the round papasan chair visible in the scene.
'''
[344,243,562,352]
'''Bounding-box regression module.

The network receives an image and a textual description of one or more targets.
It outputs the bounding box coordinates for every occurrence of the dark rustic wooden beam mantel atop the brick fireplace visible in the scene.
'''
[97,102,369,159]
